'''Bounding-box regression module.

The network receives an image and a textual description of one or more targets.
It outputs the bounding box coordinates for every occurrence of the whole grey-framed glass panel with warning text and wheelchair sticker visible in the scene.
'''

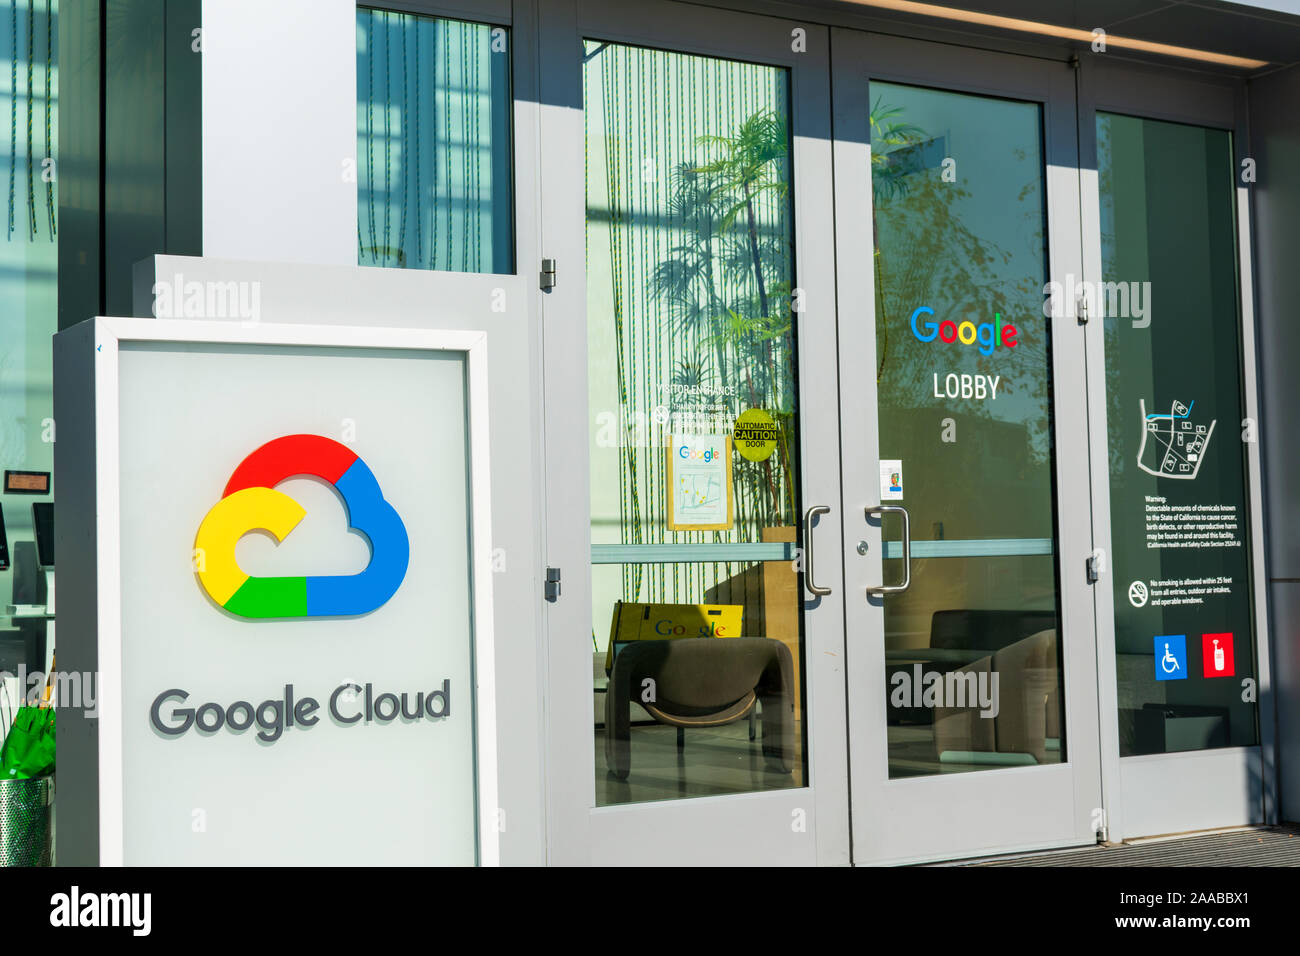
[1080,62,1275,839]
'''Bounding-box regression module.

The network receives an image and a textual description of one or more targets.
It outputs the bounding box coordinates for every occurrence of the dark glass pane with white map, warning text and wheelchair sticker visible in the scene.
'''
[1096,113,1258,756]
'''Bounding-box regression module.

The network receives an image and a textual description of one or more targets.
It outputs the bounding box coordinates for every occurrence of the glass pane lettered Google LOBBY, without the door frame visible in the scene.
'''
[871,83,1060,777]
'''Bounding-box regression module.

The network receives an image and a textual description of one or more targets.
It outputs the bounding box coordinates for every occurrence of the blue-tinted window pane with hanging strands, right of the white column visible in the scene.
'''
[356,8,515,273]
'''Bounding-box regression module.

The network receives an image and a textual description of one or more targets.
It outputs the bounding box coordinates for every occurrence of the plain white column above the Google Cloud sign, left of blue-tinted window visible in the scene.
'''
[203,0,356,265]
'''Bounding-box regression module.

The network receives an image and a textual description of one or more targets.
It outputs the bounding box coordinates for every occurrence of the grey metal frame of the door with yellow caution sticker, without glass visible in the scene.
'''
[538,0,849,865]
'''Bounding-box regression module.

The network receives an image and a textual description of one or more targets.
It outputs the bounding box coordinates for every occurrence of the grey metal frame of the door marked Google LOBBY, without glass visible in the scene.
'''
[832,29,1101,864]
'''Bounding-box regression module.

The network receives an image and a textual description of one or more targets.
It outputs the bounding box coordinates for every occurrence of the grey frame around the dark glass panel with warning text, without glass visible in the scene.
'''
[1079,56,1278,842]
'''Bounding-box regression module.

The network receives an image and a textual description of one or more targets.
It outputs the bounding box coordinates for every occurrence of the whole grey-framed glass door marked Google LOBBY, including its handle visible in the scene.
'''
[832,31,1102,862]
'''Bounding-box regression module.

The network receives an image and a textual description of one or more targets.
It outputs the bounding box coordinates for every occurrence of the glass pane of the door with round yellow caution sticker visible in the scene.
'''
[582,40,806,804]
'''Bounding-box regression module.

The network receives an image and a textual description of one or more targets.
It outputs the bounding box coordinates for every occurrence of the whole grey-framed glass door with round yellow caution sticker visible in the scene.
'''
[541,1,849,864]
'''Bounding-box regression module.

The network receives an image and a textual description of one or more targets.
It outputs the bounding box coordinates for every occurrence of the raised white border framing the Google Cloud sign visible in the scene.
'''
[68,317,499,866]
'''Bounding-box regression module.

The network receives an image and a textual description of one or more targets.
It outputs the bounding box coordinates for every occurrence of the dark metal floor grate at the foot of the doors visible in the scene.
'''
[949,823,1300,866]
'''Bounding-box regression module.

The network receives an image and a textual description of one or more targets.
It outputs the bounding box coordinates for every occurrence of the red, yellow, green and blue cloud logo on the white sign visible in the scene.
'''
[194,434,411,618]
